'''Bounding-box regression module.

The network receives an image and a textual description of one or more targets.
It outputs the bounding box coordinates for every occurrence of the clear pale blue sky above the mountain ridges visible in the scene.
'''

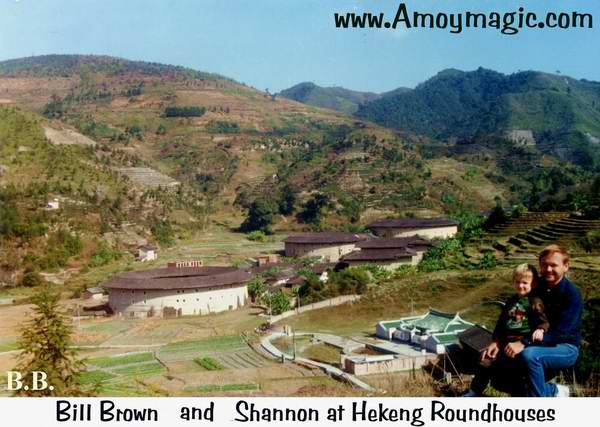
[0,0,600,92]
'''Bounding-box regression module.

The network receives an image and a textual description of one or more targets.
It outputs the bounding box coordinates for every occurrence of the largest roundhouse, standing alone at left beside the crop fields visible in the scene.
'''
[104,267,250,317]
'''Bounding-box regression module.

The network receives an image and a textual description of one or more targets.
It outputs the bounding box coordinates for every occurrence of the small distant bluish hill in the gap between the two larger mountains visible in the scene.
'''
[279,82,408,114]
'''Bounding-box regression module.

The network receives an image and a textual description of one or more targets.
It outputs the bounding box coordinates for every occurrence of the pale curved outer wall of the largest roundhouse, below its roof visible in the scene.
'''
[108,284,248,317]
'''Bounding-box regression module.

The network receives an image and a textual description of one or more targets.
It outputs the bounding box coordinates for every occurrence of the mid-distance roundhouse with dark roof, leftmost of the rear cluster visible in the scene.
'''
[284,232,368,262]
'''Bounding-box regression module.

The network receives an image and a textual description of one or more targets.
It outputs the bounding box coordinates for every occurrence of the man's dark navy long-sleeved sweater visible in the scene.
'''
[532,277,583,346]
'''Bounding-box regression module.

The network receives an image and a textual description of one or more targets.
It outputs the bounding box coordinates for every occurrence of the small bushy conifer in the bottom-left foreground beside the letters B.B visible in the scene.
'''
[14,287,85,396]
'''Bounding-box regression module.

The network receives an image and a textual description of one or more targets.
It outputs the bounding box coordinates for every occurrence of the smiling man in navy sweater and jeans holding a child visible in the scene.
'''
[504,245,583,397]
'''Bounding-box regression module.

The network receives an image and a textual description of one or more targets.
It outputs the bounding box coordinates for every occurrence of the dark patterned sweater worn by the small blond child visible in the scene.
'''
[492,293,550,347]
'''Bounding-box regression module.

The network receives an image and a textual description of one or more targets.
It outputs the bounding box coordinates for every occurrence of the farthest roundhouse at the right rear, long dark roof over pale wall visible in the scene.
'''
[367,218,458,239]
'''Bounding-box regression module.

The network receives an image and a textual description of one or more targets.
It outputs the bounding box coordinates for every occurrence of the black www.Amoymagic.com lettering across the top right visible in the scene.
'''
[334,3,593,35]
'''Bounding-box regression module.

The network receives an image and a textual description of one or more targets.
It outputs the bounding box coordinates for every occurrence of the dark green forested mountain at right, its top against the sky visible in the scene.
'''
[356,68,600,169]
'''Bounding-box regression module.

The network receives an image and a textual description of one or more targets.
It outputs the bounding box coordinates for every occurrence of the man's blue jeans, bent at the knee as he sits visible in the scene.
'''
[519,344,579,397]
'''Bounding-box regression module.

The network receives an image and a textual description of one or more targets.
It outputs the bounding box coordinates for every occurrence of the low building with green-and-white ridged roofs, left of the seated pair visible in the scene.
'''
[375,309,474,354]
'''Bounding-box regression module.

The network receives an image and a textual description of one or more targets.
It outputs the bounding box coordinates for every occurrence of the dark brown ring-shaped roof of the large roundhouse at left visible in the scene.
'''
[103,267,250,290]
